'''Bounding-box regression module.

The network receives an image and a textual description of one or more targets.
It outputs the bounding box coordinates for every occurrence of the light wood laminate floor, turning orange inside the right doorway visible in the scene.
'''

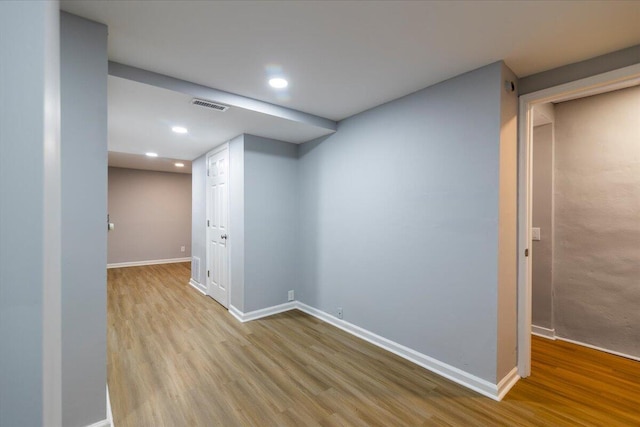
[108,263,640,427]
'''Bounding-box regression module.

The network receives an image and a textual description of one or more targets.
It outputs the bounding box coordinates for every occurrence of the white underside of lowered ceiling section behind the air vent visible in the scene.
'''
[108,76,333,160]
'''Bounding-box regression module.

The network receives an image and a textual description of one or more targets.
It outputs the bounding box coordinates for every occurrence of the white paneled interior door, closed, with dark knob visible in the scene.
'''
[207,146,229,307]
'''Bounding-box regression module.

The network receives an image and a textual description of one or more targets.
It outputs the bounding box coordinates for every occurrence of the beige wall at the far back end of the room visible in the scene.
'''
[105,168,191,264]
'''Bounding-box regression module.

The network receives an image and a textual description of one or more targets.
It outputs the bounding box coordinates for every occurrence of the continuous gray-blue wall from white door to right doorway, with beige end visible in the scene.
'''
[185,62,517,384]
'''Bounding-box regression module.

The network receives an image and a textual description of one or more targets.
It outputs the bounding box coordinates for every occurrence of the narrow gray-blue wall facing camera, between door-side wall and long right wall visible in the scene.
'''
[242,135,299,312]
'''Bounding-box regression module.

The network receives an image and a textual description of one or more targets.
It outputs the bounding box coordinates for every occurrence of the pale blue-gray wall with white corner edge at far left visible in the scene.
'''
[0,2,59,427]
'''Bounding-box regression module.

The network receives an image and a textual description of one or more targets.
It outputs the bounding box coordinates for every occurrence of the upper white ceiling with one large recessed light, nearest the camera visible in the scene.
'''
[61,0,640,120]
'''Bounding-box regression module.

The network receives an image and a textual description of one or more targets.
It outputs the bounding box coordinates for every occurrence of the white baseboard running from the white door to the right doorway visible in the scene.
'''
[229,301,520,401]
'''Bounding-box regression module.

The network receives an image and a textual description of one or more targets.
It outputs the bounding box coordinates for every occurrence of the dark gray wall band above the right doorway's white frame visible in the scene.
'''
[518,45,640,95]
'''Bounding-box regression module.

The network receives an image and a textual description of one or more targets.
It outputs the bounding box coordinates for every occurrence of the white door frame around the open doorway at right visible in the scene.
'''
[518,64,640,378]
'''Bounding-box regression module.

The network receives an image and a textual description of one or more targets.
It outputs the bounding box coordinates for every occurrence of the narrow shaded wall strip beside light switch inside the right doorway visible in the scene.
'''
[531,124,553,329]
